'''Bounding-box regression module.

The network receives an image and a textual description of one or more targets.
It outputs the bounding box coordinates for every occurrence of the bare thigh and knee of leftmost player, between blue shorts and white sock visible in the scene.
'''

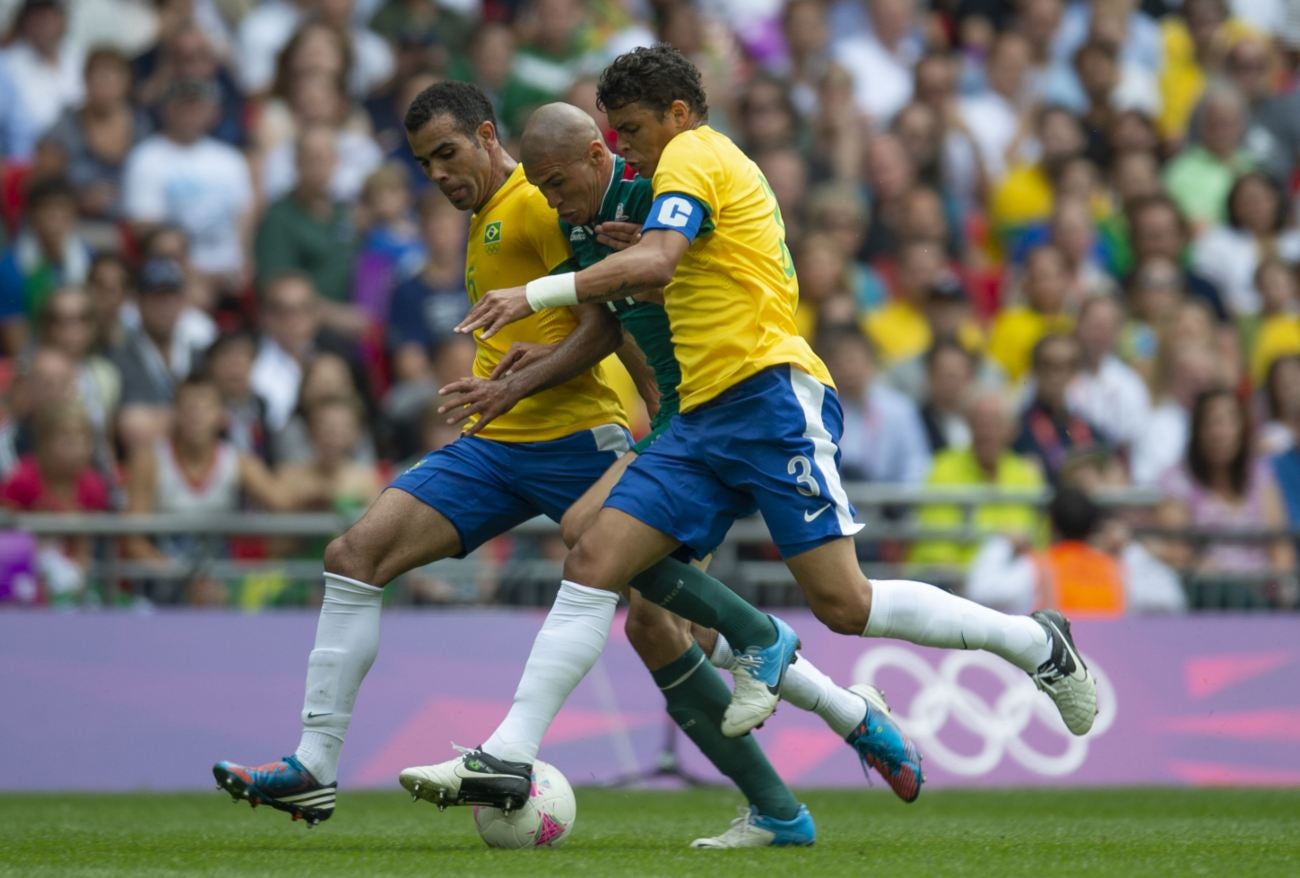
[325,488,460,587]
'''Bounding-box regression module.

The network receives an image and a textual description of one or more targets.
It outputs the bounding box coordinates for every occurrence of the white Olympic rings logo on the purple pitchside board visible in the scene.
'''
[853,645,1118,777]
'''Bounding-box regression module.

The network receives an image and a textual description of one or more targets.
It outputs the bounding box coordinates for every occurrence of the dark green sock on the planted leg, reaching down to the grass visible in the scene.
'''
[650,643,800,819]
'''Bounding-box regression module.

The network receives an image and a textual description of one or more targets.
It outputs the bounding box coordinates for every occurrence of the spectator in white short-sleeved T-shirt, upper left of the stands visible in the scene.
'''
[122,79,255,286]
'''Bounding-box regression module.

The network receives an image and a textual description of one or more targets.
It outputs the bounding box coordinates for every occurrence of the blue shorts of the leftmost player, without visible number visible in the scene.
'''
[389,424,632,558]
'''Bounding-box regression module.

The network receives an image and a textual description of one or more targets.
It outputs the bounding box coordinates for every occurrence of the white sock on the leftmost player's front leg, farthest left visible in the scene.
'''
[294,574,384,783]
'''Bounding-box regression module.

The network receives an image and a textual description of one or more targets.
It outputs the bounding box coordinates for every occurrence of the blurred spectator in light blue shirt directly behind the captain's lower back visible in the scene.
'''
[818,325,930,485]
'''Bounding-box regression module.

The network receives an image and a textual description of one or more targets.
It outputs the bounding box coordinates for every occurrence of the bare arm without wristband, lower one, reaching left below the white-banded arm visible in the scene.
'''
[438,306,623,436]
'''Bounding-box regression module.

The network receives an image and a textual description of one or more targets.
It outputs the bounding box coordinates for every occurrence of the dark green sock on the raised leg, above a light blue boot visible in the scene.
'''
[631,558,776,649]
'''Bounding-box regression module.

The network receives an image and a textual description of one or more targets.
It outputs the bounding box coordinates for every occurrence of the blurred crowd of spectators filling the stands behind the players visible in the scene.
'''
[0,0,1300,609]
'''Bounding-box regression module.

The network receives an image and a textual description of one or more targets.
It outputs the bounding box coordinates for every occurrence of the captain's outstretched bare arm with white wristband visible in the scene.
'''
[456,229,690,338]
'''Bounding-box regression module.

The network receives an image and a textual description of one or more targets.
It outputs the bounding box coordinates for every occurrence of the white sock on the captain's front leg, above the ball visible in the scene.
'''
[482,579,619,764]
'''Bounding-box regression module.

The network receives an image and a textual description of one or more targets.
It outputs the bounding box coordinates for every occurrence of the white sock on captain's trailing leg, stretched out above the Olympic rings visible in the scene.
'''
[862,579,1052,672]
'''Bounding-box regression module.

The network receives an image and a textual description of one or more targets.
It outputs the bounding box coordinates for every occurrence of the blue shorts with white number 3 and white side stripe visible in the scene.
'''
[605,366,862,558]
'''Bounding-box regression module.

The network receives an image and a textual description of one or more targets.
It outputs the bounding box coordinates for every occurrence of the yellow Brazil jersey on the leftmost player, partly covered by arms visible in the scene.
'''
[465,165,627,442]
